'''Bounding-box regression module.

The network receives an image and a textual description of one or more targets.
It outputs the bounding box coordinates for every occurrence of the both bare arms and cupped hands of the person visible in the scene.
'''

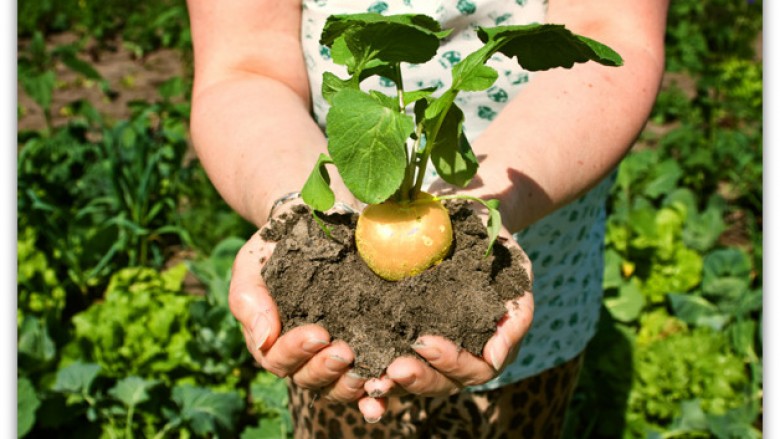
[188,0,668,421]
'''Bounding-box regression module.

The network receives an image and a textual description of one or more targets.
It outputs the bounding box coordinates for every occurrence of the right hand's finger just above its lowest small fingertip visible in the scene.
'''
[387,357,462,396]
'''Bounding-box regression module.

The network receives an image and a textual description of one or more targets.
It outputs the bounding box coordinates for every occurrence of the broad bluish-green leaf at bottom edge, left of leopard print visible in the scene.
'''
[173,385,244,436]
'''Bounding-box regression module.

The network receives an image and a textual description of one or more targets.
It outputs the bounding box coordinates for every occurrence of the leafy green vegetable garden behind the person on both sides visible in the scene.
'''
[17,0,763,439]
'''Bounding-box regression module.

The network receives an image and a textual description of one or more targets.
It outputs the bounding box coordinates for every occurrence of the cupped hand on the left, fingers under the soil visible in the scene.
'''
[229,217,365,402]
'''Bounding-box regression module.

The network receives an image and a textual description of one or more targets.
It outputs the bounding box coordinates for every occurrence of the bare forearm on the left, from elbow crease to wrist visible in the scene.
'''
[191,73,326,226]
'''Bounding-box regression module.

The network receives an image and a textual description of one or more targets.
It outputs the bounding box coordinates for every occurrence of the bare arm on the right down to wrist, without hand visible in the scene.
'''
[450,0,668,231]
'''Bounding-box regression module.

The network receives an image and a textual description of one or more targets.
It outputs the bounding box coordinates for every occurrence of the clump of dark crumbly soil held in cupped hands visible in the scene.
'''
[262,201,531,377]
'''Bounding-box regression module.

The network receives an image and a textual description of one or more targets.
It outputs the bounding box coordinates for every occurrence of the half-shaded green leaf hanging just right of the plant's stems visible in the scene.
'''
[431,104,479,187]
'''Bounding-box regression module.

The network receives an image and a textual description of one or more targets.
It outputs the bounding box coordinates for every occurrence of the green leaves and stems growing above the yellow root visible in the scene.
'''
[302,13,622,210]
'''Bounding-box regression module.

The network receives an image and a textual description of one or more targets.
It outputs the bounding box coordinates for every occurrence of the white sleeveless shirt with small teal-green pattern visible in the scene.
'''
[301,0,611,390]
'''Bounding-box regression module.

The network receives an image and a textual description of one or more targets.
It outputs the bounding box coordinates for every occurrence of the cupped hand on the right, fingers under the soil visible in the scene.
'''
[365,229,534,406]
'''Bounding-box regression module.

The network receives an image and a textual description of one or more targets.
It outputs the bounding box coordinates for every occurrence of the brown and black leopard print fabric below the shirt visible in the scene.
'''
[288,355,582,439]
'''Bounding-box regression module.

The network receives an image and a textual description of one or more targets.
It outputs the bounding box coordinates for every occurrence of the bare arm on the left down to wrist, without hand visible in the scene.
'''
[188,0,350,226]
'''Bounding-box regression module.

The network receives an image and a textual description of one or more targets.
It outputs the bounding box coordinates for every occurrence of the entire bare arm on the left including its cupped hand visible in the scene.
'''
[188,0,368,416]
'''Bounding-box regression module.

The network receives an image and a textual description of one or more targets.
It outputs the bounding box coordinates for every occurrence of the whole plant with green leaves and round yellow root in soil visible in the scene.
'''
[301,13,622,280]
